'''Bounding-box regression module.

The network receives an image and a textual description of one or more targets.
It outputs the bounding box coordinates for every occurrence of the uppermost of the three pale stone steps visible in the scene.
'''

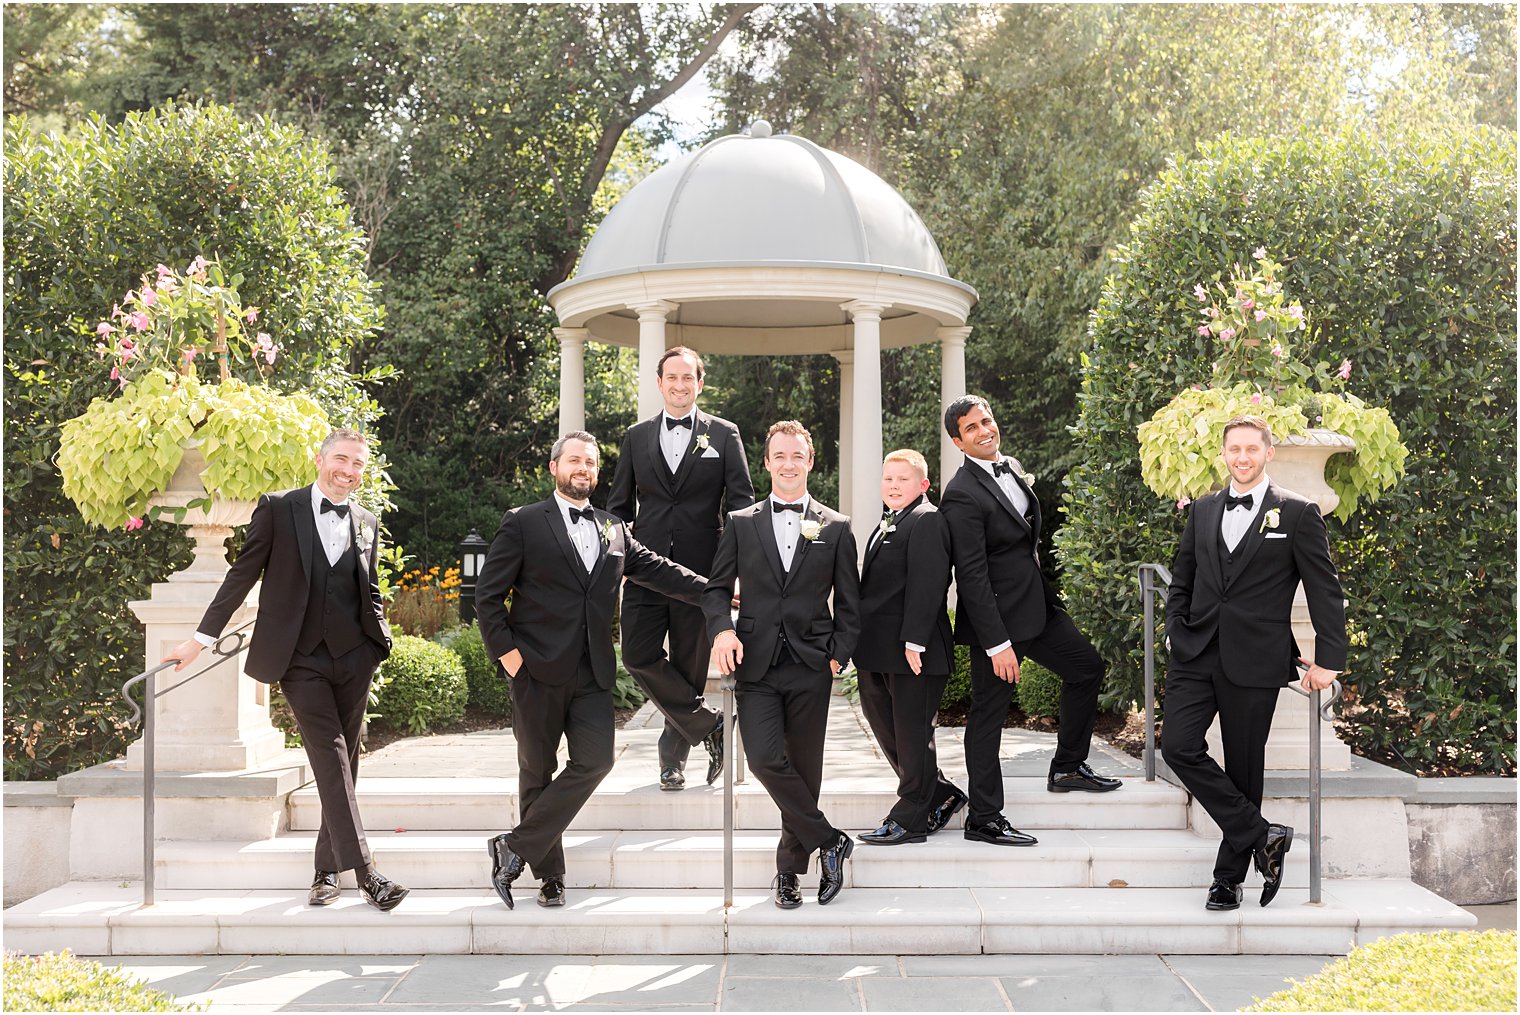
[290,770,1187,831]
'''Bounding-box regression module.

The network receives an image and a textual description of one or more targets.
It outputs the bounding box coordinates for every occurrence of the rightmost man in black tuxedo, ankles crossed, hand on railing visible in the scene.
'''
[1161,416,1347,910]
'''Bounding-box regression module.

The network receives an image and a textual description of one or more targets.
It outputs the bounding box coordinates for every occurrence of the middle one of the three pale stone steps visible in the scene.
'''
[155,830,1309,890]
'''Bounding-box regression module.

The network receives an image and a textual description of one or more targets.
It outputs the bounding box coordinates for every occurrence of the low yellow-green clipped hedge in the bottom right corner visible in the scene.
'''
[1242,930,1515,1012]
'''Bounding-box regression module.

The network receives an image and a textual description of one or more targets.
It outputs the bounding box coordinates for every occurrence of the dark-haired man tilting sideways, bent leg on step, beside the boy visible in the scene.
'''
[939,395,1120,846]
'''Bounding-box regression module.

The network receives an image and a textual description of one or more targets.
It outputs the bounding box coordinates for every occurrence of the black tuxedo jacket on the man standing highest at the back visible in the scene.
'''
[606,409,755,573]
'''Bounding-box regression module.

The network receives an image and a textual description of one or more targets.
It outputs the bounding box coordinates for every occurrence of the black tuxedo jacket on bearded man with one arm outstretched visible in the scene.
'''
[476,495,705,687]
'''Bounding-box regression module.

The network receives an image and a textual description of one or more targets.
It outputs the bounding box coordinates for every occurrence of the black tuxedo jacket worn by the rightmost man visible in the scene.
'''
[1166,482,1347,687]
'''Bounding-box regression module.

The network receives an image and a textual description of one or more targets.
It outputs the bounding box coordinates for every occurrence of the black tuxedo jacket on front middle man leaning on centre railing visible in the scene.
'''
[702,497,860,681]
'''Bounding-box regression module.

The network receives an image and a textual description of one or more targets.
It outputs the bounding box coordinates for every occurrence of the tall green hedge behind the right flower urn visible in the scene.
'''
[1058,129,1515,773]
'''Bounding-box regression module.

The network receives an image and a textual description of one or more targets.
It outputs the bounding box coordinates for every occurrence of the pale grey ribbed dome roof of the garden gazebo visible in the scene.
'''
[567,130,947,284]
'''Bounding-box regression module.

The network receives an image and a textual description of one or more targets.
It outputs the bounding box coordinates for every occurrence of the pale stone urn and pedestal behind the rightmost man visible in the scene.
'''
[1208,430,1356,772]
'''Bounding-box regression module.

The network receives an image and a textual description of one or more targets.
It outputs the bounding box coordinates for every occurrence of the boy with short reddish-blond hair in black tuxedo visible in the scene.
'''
[854,448,965,846]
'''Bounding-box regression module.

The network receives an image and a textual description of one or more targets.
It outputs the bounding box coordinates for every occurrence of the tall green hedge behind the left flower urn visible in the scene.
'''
[3,106,380,779]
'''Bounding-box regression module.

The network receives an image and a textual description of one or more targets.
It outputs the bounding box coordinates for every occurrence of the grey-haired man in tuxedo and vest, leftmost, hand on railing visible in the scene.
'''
[166,428,407,913]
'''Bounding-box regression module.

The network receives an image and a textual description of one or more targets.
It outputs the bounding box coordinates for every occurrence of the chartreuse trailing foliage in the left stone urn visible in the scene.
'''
[58,371,330,529]
